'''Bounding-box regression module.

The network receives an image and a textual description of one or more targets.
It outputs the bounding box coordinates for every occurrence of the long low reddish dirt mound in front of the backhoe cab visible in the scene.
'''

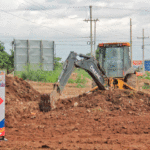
[57,89,150,113]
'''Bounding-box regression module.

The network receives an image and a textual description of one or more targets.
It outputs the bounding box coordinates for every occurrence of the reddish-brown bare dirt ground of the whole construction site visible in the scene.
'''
[0,76,150,150]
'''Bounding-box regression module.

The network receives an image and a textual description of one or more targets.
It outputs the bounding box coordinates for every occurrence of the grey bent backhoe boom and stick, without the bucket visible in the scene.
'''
[54,52,105,93]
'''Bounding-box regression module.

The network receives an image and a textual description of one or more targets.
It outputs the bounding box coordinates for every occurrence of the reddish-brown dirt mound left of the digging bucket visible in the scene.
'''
[5,76,40,127]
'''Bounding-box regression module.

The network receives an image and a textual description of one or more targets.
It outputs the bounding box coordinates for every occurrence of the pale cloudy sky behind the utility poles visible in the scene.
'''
[0,0,150,61]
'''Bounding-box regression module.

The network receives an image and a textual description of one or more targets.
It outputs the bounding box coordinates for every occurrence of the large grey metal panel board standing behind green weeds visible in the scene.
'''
[14,40,54,71]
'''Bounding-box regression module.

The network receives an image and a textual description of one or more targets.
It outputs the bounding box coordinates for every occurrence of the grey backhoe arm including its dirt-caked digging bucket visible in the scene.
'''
[39,51,105,112]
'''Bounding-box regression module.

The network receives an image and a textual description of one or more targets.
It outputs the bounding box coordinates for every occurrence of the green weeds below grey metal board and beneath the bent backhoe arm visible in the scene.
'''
[15,63,91,88]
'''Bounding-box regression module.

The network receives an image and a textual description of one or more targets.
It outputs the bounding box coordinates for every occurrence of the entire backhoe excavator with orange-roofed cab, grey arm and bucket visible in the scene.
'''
[39,43,136,112]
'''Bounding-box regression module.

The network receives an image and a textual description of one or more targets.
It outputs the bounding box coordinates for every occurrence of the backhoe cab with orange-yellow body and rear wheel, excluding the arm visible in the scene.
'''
[98,43,136,89]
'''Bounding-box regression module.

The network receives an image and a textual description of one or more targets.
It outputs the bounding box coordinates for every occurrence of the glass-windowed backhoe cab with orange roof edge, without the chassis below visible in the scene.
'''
[98,43,131,78]
